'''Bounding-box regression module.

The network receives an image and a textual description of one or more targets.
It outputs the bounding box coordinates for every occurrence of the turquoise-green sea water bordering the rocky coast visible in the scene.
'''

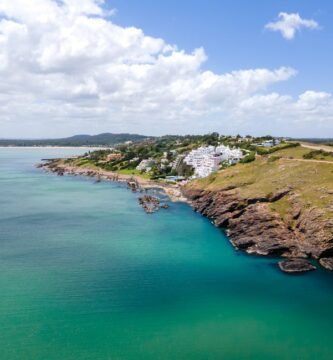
[0,149,333,360]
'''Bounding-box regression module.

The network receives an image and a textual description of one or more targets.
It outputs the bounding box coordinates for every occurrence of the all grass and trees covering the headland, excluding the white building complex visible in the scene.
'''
[55,133,333,224]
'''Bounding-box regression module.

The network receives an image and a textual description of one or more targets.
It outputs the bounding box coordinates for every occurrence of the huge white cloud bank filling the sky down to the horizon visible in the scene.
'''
[0,0,333,137]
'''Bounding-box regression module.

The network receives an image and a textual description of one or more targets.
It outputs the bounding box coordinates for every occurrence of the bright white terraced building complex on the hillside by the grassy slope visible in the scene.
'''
[184,145,243,178]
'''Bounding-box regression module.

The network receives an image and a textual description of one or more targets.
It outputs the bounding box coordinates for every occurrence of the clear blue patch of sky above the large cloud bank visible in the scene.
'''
[107,0,333,95]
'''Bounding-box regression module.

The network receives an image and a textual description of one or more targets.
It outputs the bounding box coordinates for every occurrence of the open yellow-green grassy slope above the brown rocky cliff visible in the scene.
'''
[190,147,333,217]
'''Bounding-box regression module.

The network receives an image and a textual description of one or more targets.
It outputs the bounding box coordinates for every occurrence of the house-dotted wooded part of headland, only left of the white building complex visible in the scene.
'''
[73,133,220,180]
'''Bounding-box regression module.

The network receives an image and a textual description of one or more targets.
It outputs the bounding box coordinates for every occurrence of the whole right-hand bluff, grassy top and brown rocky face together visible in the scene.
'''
[183,147,333,272]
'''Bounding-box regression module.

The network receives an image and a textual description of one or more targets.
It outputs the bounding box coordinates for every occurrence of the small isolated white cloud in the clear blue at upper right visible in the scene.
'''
[265,12,319,40]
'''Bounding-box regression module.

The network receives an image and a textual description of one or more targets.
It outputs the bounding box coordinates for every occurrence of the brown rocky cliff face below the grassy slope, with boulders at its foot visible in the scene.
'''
[184,186,333,273]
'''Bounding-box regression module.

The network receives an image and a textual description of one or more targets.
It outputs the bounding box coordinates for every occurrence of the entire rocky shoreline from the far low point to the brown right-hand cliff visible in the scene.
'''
[38,160,333,273]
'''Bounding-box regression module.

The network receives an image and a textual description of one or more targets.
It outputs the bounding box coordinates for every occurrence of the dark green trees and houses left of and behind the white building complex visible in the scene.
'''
[59,132,312,180]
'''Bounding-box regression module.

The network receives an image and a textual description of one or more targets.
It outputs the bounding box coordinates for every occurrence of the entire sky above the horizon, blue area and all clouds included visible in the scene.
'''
[0,0,333,138]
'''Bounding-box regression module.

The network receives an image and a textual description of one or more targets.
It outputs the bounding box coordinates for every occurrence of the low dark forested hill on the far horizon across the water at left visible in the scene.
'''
[0,133,150,146]
